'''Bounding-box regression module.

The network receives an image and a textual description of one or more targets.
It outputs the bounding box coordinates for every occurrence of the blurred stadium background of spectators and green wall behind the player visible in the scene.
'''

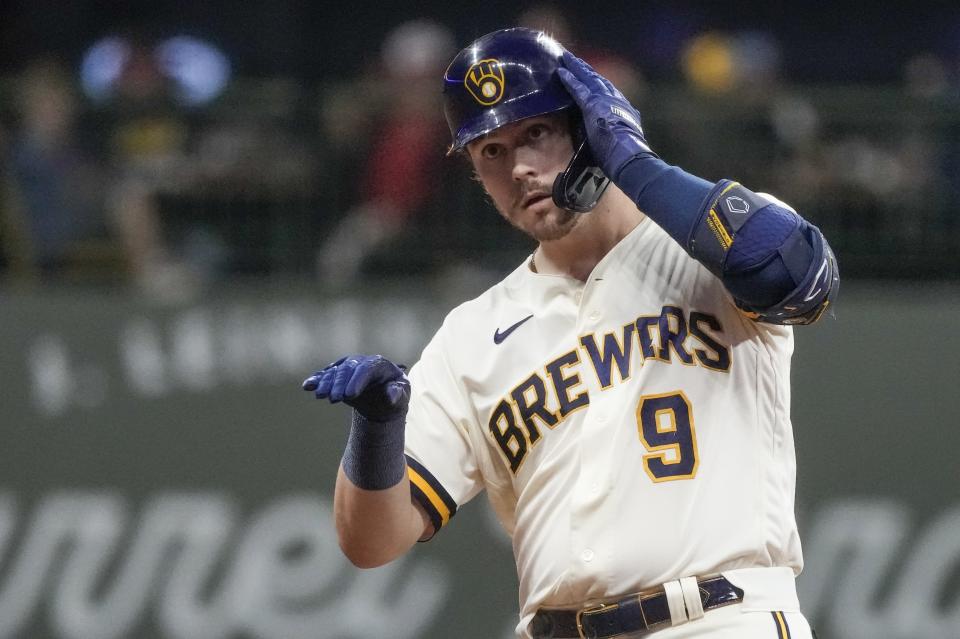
[0,0,960,639]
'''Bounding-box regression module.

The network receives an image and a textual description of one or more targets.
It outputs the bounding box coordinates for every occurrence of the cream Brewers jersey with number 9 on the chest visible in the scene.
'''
[406,219,802,631]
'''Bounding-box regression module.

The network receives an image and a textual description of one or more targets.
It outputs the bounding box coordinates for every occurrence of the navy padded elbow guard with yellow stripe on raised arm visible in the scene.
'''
[687,180,840,324]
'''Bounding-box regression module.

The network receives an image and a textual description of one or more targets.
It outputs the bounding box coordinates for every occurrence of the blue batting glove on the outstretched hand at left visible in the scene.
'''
[303,355,410,422]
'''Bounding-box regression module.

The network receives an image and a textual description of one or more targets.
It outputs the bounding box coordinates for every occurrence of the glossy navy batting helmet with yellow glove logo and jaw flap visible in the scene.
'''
[443,27,610,213]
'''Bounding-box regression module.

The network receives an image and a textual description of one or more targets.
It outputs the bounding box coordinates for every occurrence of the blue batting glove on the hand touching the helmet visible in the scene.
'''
[557,51,656,182]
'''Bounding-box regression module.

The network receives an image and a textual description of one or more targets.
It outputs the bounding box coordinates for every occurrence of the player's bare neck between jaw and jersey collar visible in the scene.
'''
[534,185,644,282]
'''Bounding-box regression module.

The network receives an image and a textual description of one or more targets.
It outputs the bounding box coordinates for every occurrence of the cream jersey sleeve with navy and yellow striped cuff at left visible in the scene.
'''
[405,329,483,531]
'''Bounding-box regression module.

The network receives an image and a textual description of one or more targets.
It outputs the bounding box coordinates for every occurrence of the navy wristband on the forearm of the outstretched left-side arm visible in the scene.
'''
[341,409,406,490]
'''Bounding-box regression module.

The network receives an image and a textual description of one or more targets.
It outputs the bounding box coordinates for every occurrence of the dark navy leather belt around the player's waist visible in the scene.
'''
[530,577,743,639]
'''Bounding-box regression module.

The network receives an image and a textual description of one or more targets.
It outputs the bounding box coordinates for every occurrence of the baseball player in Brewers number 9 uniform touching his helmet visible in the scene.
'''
[304,29,838,639]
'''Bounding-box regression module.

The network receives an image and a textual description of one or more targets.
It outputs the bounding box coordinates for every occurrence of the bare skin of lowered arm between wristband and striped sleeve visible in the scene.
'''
[333,466,431,568]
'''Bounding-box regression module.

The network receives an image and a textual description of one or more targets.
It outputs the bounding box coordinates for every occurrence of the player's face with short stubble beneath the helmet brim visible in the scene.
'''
[467,113,580,242]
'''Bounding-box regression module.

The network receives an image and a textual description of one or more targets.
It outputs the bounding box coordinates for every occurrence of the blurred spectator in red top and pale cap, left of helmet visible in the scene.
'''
[317,20,454,286]
